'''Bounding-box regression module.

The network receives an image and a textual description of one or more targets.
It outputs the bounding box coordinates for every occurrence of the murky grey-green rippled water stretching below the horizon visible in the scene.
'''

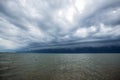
[0,53,120,80]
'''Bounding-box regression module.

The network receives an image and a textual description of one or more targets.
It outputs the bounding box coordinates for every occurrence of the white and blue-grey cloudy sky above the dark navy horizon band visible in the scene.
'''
[0,0,120,51]
